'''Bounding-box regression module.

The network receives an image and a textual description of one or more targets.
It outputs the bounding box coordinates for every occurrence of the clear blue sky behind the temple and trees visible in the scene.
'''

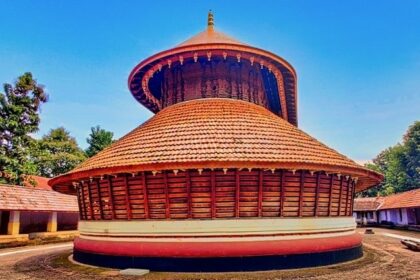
[0,0,420,161]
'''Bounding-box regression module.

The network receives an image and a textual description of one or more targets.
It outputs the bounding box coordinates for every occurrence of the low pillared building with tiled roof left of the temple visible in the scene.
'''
[0,176,79,237]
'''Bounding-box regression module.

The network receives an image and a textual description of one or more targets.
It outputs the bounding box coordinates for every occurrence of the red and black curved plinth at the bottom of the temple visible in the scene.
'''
[74,234,362,271]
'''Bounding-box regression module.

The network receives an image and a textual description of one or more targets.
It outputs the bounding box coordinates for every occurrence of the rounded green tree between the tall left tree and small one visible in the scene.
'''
[33,127,85,178]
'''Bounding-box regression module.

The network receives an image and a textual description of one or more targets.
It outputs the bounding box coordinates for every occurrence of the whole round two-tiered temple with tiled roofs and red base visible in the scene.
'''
[49,13,383,271]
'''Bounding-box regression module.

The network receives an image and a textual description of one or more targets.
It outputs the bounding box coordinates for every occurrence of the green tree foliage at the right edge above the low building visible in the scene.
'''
[361,121,420,196]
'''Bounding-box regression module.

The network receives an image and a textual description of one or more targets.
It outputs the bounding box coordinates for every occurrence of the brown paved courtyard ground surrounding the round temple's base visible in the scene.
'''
[0,228,420,280]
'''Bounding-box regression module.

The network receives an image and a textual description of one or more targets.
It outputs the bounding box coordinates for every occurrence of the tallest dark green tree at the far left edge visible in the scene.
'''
[0,72,48,184]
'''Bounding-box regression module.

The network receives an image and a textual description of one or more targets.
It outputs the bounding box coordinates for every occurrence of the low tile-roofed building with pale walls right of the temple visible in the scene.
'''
[353,188,420,230]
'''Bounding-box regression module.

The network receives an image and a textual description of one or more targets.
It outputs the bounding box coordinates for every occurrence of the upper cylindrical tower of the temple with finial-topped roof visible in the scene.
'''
[128,12,297,126]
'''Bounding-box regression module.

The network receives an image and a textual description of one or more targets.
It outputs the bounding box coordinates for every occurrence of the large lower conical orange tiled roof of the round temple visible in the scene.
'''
[50,98,382,189]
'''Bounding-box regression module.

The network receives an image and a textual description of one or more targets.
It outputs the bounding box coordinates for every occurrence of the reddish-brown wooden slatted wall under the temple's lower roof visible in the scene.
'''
[77,169,355,220]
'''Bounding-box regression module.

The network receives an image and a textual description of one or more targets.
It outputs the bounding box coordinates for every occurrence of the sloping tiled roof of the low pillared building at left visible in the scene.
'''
[0,184,79,212]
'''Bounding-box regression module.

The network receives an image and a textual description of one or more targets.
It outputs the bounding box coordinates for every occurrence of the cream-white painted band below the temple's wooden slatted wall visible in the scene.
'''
[79,217,356,237]
